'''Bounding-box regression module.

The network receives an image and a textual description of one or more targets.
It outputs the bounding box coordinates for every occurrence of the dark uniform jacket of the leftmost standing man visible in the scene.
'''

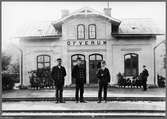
[51,66,66,85]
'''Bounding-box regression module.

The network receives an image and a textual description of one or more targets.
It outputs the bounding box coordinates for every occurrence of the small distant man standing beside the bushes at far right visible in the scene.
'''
[142,65,149,91]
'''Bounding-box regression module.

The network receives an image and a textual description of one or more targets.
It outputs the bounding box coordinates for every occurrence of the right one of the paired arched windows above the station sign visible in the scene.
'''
[88,24,96,39]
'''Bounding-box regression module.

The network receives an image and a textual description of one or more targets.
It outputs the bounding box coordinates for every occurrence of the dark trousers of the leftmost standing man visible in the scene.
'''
[56,86,63,101]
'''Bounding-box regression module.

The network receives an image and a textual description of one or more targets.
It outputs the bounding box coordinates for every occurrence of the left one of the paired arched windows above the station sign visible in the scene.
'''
[77,24,85,40]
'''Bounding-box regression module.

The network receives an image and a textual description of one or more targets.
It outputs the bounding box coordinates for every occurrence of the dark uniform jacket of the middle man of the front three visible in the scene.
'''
[72,65,86,84]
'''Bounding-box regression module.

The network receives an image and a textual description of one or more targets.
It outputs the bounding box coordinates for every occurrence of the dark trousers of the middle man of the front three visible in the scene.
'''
[75,83,84,101]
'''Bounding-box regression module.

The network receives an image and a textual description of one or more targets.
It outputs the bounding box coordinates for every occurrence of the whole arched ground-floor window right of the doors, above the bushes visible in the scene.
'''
[124,53,138,76]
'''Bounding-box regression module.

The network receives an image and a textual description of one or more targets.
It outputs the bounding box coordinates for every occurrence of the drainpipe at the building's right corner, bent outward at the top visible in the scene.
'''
[153,40,165,85]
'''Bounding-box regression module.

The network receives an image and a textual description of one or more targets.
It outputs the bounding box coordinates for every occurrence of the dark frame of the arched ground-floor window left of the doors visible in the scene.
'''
[36,54,51,70]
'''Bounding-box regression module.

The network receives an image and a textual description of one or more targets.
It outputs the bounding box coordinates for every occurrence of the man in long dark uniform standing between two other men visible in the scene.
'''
[72,57,86,103]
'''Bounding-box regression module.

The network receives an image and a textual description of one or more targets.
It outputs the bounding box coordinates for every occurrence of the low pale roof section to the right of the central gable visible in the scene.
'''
[112,18,164,35]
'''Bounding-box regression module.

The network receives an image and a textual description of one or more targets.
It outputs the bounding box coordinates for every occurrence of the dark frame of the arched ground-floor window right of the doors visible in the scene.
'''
[124,53,139,76]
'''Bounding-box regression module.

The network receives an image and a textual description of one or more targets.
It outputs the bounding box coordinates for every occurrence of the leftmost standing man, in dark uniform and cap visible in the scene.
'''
[52,58,66,103]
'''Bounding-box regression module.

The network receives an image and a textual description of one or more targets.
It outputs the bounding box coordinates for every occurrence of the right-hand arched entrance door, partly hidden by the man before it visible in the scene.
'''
[89,54,103,84]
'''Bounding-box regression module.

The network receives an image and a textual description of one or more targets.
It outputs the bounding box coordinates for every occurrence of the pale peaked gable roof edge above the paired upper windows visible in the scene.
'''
[53,7,121,25]
